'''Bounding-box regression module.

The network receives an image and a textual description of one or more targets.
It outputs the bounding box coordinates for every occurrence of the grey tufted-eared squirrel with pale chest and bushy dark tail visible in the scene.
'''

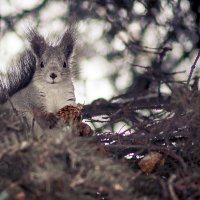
[0,25,76,129]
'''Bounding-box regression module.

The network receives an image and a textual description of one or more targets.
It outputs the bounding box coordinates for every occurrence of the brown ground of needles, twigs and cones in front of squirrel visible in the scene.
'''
[0,76,200,200]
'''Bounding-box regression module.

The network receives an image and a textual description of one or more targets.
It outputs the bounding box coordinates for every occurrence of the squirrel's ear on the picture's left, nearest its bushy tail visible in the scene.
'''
[26,29,47,58]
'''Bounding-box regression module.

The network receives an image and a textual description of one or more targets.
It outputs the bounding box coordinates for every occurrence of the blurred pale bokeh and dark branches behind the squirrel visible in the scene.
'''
[0,0,200,104]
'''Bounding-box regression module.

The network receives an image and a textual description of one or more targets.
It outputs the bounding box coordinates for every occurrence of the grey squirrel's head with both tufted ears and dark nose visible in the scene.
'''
[27,26,76,84]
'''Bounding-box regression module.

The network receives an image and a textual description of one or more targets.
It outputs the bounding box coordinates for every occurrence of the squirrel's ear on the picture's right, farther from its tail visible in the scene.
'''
[59,24,77,59]
